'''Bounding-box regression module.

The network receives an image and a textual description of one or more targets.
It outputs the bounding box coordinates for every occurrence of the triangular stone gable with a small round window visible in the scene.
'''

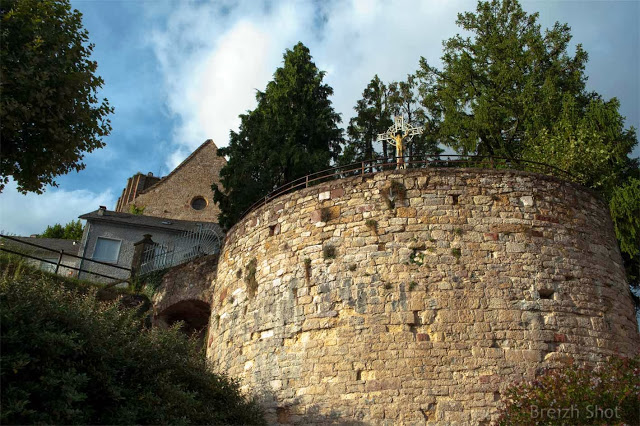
[117,140,226,222]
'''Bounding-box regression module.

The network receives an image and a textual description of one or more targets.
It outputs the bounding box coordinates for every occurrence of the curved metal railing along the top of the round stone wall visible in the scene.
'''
[239,155,575,219]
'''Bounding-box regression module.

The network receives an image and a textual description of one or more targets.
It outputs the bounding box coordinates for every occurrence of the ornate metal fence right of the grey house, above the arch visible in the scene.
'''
[139,224,223,275]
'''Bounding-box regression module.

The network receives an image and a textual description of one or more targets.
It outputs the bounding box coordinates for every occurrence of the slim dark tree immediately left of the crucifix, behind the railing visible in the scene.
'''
[339,75,393,164]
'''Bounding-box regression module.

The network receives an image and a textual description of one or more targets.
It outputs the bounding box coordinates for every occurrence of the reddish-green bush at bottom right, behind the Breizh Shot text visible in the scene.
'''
[497,356,640,425]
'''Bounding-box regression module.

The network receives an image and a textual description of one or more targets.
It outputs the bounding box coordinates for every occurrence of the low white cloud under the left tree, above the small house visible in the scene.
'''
[0,181,116,236]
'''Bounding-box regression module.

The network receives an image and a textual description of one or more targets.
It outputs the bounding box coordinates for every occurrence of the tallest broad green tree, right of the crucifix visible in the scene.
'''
[417,0,589,158]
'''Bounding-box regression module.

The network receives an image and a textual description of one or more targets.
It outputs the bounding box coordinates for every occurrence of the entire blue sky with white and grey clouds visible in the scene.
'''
[0,0,640,235]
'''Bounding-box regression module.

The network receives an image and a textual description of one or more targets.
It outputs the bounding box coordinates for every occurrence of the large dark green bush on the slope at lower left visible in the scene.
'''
[0,262,264,424]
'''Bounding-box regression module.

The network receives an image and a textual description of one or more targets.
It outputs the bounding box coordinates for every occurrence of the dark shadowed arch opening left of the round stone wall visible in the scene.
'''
[155,299,211,343]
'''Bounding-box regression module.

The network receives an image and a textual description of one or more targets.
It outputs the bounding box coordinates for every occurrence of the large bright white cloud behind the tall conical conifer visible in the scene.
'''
[150,0,473,168]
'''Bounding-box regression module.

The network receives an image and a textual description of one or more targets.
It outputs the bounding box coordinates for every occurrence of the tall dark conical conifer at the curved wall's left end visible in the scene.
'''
[212,43,343,228]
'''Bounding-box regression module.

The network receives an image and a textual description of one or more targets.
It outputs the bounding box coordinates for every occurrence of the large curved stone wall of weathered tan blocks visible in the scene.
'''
[207,169,640,424]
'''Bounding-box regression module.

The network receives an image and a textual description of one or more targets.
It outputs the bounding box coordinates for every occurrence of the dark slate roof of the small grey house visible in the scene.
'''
[80,209,223,235]
